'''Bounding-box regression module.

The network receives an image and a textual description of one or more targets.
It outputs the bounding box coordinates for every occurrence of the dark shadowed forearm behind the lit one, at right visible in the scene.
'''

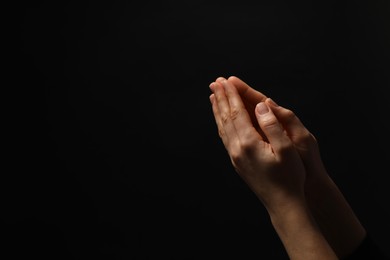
[306,173,366,258]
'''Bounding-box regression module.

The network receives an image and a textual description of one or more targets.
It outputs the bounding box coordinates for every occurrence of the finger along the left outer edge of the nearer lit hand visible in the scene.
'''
[212,82,238,150]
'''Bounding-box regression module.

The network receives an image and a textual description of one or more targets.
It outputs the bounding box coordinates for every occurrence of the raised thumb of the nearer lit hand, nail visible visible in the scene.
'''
[256,102,292,155]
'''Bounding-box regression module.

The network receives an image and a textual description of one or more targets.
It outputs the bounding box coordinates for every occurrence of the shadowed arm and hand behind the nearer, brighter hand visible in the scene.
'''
[227,77,366,258]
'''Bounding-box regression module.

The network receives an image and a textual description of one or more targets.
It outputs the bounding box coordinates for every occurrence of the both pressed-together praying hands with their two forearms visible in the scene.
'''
[210,77,366,259]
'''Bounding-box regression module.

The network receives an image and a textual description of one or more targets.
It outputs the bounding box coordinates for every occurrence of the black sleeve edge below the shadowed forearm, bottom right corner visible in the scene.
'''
[344,234,390,260]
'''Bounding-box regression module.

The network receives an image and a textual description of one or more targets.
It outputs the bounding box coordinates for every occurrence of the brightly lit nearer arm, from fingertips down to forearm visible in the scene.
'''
[210,80,337,259]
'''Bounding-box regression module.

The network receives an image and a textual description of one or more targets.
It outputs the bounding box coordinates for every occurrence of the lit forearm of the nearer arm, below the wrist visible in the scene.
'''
[268,198,338,260]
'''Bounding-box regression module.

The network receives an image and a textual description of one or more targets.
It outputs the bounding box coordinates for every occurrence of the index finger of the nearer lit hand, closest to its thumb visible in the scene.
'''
[221,80,260,139]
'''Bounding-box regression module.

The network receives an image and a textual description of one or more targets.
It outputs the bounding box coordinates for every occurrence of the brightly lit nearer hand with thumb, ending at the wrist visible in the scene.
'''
[210,80,306,211]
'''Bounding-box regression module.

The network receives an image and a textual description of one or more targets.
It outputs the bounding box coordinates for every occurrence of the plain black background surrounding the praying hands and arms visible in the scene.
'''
[9,0,390,260]
